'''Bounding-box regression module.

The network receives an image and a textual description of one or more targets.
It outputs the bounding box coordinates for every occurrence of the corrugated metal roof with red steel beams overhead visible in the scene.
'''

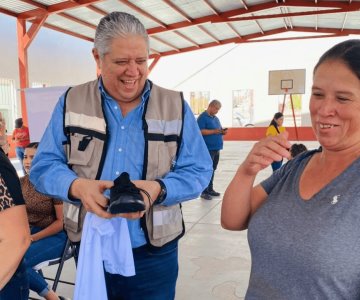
[0,0,360,57]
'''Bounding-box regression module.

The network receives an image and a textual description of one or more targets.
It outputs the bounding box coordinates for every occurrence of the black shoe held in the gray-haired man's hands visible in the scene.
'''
[108,172,145,214]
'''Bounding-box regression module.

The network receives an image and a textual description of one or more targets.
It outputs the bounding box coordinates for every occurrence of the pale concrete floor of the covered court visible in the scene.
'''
[24,141,318,300]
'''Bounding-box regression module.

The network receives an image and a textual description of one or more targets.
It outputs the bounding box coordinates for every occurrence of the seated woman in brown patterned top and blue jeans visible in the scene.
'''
[20,143,66,300]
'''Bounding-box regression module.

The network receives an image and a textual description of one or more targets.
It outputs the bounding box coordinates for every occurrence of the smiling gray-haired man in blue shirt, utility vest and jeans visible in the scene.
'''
[30,12,212,300]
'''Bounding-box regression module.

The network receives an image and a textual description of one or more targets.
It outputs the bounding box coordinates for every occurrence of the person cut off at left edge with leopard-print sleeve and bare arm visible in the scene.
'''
[0,149,30,300]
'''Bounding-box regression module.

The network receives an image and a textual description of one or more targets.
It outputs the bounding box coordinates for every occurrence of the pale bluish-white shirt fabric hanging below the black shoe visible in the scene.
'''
[74,212,135,300]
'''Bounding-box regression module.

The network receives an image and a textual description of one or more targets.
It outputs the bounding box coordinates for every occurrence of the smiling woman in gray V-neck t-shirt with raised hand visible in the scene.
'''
[221,40,360,300]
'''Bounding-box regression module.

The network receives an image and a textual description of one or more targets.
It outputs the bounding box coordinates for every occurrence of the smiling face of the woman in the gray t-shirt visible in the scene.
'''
[310,59,360,151]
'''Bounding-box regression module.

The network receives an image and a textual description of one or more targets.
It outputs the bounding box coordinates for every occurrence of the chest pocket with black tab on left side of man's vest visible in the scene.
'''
[68,133,95,166]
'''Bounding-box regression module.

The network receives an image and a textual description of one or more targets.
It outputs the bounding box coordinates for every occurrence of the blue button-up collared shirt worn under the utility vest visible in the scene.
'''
[30,80,212,248]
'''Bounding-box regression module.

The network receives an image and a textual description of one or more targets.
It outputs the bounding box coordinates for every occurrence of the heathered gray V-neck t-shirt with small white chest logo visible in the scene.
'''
[245,151,360,300]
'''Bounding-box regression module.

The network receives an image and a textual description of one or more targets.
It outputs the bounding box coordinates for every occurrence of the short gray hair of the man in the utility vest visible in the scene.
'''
[94,11,150,58]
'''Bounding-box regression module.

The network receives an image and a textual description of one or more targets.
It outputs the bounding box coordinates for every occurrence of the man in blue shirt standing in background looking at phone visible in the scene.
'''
[197,100,227,200]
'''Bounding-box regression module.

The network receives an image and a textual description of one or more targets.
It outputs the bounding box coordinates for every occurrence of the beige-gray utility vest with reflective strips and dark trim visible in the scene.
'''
[64,80,185,247]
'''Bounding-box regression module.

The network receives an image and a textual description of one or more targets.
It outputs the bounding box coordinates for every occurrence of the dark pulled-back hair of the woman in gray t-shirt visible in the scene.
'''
[314,39,360,79]
